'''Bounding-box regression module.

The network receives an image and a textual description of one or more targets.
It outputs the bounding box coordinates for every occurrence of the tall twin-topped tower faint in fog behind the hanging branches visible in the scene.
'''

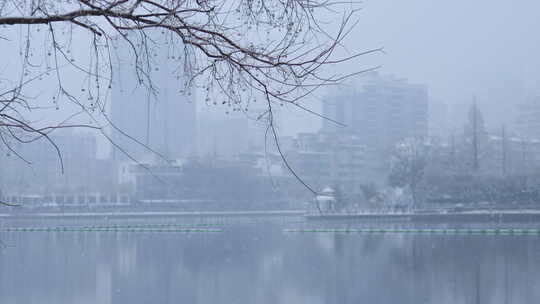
[111,37,197,161]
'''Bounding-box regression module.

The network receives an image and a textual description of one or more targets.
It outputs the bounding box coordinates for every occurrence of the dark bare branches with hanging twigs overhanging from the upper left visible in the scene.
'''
[0,0,381,195]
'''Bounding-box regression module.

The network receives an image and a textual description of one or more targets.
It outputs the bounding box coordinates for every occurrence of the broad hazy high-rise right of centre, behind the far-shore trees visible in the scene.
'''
[323,73,428,150]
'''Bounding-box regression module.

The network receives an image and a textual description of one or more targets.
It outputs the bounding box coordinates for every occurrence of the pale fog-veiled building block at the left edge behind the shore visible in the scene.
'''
[0,129,103,195]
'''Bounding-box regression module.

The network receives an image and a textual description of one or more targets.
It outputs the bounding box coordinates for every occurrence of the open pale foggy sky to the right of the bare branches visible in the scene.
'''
[282,0,540,134]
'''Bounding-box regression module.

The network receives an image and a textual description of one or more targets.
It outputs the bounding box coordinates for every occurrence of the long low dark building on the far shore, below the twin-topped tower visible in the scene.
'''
[119,155,302,209]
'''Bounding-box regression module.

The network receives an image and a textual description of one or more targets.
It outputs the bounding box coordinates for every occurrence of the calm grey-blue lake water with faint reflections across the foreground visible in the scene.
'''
[0,220,540,304]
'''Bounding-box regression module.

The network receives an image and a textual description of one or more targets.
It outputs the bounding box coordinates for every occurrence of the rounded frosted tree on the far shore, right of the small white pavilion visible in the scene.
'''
[388,138,429,207]
